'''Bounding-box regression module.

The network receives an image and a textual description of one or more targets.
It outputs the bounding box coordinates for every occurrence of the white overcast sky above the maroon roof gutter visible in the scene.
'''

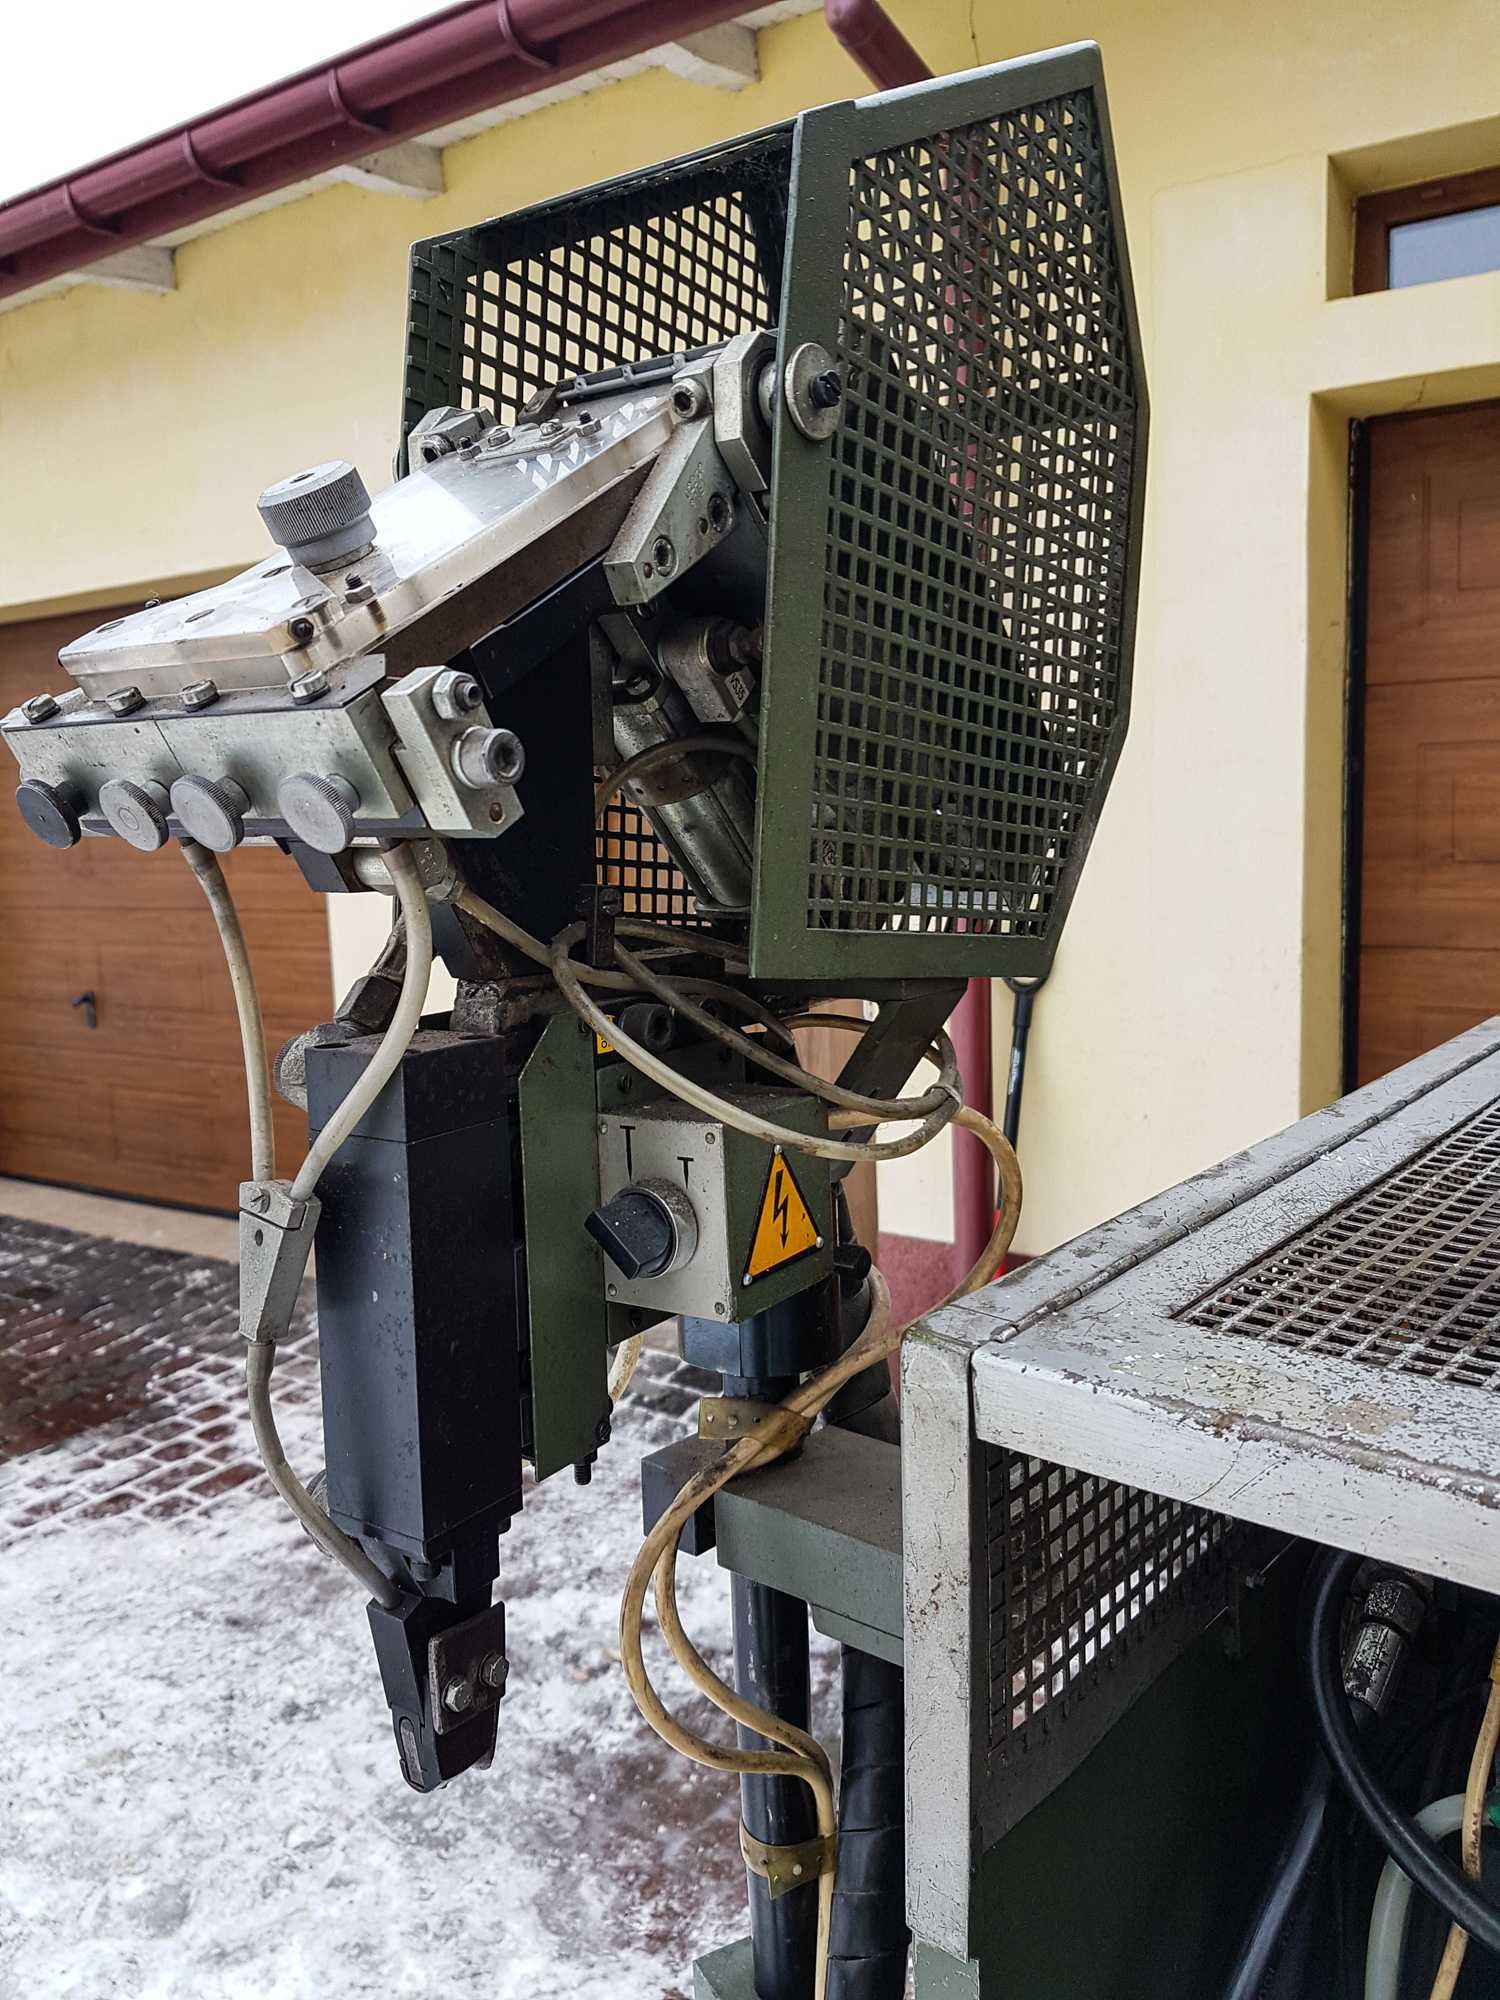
[0,0,452,200]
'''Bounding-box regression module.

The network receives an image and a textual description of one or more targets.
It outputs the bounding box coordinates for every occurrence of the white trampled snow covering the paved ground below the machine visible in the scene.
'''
[0,1266,848,2000]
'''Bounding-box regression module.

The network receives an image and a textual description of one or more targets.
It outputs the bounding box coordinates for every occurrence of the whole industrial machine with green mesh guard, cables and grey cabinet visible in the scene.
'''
[4,48,1500,2000]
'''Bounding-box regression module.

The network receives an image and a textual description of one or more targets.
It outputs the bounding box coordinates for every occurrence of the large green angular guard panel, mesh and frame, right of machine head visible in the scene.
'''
[752,48,1144,978]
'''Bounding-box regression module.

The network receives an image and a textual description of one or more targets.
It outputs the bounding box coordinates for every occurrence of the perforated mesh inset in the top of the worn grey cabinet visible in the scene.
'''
[1174,1104,1500,1390]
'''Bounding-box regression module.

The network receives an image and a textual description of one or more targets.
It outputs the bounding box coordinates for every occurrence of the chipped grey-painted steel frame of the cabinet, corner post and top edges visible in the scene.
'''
[902,1020,1500,1960]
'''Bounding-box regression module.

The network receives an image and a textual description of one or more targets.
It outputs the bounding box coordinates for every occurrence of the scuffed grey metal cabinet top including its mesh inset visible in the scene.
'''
[974,1024,1500,1590]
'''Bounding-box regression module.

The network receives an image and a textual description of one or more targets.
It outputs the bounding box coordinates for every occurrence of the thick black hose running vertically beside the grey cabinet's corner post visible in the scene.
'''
[828,1646,908,2000]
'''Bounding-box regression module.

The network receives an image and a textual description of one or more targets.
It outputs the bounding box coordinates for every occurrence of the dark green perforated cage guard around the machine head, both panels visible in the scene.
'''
[404,44,1146,992]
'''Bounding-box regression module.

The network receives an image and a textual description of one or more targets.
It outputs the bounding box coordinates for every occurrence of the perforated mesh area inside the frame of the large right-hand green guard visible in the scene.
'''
[808,92,1134,938]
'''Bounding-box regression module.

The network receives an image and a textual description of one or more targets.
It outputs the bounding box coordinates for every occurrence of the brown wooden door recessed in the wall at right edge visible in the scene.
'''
[1356,404,1500,1082]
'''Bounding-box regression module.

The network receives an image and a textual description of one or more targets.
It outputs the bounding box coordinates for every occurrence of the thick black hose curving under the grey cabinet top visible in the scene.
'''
[1304,1550,1500,1956]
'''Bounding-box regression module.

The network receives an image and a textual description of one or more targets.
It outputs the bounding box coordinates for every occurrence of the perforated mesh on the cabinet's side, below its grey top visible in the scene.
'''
[984,1448,1234,1760]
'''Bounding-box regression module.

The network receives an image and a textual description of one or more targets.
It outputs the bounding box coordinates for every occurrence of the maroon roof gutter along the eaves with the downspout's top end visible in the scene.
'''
[0,0,928,298]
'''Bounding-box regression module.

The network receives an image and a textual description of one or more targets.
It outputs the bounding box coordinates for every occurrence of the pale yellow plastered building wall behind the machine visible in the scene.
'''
[0,0,1500,1250]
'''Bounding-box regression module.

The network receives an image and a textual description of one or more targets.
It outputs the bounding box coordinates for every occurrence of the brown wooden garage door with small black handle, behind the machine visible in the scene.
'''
[0,606,330,1208]
